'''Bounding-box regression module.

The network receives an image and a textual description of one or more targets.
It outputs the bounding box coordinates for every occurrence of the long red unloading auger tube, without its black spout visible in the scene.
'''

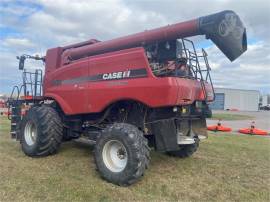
[46,19,200,71]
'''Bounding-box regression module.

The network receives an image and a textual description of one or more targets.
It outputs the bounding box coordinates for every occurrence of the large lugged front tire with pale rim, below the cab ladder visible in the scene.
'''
[20,105,63,157]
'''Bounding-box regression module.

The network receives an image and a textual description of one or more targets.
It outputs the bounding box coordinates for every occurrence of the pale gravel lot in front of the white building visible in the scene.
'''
[207,110,270,132]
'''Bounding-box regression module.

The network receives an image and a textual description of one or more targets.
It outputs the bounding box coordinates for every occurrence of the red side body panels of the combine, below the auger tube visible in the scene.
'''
[44,48,212,115]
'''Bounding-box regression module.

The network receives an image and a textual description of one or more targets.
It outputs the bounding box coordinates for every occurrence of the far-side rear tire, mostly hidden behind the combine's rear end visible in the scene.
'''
[167,141,199,158]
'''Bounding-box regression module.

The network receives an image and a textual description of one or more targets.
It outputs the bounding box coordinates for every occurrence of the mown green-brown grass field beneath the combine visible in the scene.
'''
[0,118,270,202]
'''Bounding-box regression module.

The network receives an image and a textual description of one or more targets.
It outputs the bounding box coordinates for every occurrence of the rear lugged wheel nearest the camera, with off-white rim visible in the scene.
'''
[94,123,150,186]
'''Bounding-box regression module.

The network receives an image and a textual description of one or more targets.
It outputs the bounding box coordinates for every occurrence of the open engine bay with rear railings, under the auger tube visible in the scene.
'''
[145,39,210,80]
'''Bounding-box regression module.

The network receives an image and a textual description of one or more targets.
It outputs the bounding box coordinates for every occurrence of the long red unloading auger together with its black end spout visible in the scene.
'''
[43,11,247,71]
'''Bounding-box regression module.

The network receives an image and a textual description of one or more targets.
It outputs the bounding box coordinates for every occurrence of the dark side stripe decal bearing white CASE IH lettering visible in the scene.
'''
[52,68,147,86]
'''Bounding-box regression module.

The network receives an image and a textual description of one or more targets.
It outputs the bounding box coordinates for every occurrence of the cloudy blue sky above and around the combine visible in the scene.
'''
[0,0,270,94]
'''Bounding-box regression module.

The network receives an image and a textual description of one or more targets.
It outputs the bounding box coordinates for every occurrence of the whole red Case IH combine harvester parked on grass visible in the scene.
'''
[9,11,247,186]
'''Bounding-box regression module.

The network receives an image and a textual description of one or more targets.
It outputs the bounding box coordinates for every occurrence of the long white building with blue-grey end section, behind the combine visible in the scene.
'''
[210,88,260,111]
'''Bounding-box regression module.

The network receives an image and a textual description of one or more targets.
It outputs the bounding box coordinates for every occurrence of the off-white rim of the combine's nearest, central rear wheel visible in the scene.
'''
[102,140,128,172]
